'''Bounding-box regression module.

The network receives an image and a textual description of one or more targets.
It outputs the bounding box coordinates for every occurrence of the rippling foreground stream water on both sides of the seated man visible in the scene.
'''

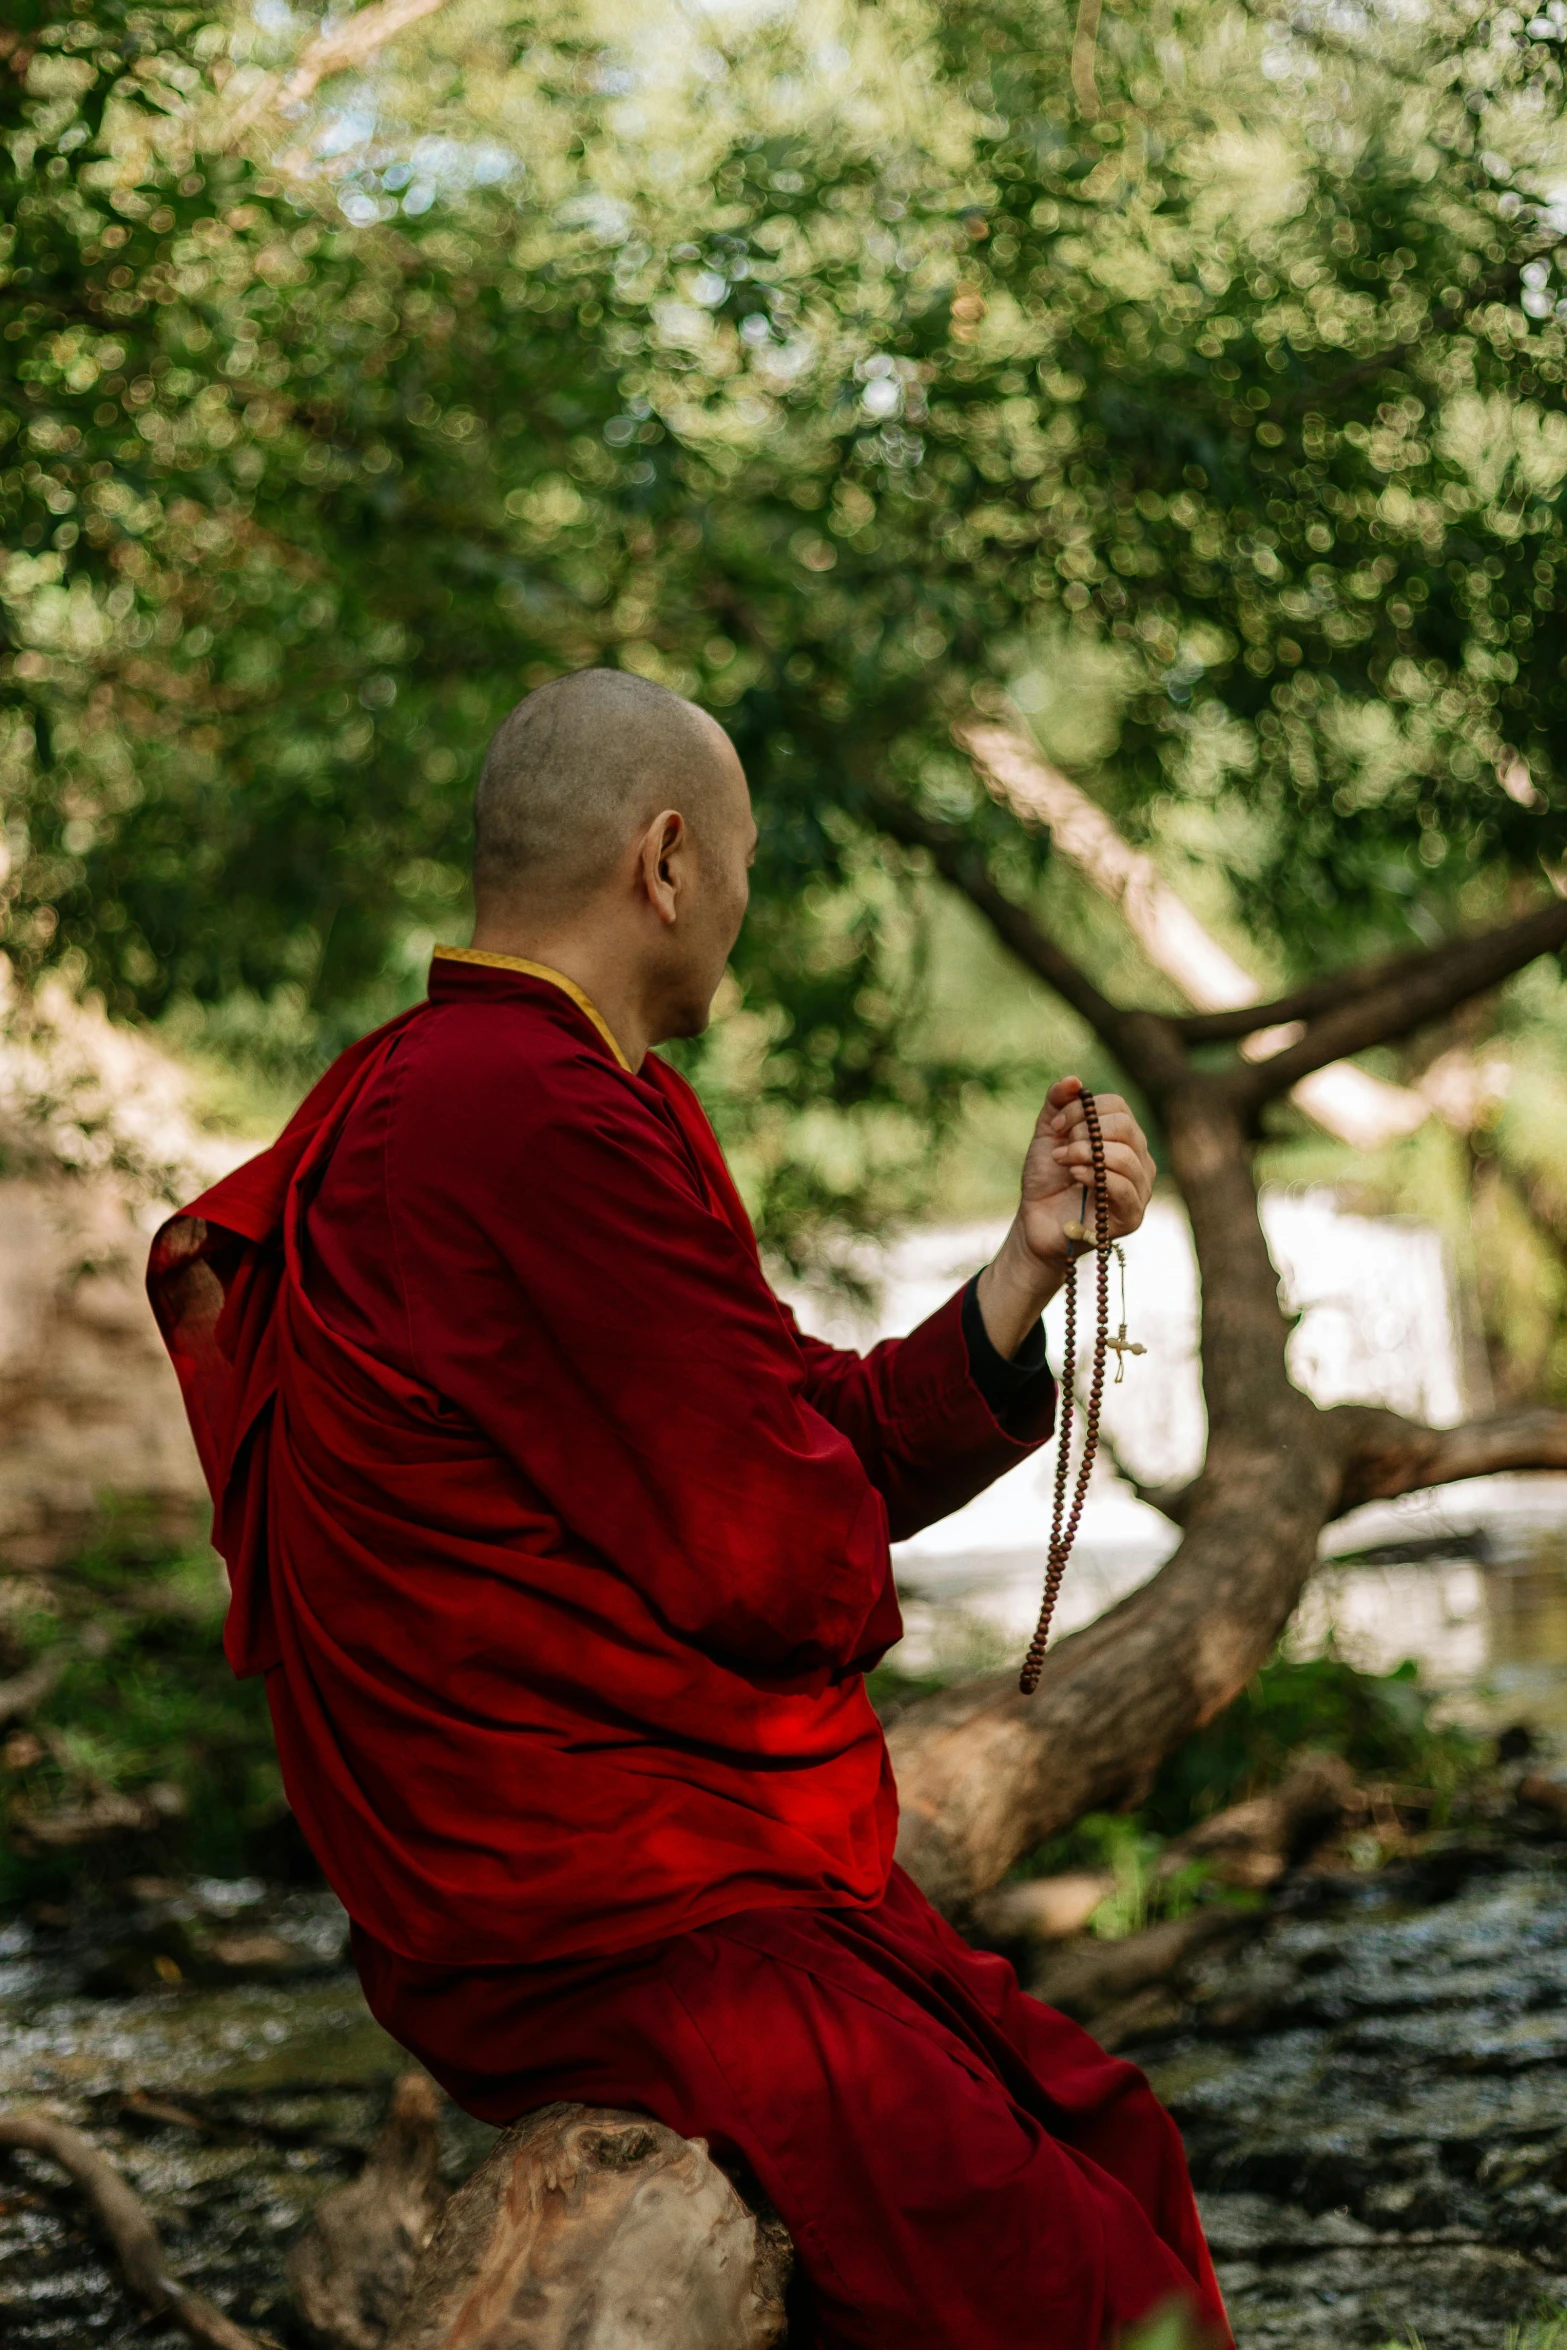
[0,1838,1567,2350]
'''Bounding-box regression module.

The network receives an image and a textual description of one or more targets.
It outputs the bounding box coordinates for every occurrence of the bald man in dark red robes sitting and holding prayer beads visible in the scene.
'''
[150,670,1226,2350]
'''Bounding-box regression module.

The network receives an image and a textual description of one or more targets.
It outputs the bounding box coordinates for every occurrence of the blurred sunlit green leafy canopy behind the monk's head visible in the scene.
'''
[0,0,1567,1241]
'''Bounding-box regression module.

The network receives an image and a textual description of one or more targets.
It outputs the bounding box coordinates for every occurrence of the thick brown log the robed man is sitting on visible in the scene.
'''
[385,2106,792,2350]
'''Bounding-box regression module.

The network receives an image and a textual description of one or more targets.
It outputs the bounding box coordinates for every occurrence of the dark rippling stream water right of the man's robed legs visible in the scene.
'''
[1130,1845,1567,2350]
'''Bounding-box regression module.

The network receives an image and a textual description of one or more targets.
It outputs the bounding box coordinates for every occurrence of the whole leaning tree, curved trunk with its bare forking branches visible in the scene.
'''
[876,745,1567,1915]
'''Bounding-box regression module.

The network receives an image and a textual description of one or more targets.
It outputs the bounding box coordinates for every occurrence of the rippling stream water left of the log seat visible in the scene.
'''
[0,1880,493,2350]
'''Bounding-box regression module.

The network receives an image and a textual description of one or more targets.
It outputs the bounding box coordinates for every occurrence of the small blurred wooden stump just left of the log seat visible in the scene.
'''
[289,2073,446,2350]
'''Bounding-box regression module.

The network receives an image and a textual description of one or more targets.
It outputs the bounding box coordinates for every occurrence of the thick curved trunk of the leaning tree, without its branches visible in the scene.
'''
[888,1081,1339,1911]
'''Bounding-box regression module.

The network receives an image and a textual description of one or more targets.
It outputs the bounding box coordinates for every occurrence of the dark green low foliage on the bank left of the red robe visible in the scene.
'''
[0,1528,298,1901]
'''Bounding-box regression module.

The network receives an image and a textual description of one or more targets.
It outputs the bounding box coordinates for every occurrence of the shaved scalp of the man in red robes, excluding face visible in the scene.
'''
[475,670,742,917]
